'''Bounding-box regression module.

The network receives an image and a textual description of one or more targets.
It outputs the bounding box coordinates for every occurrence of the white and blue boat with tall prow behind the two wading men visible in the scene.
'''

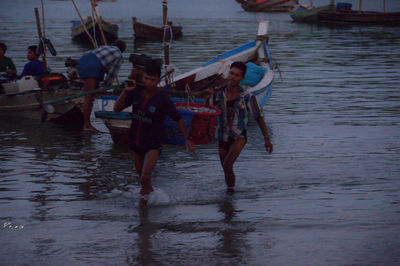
[95,22,274,146]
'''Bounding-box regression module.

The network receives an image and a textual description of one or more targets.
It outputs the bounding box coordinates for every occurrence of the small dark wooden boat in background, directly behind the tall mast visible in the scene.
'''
[132,17,182,41]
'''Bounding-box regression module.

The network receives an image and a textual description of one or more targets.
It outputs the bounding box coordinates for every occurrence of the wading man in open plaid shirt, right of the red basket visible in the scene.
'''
[208,62,273,193]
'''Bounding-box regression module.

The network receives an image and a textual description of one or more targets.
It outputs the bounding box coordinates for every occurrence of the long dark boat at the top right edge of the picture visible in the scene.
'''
[318,0,400,25]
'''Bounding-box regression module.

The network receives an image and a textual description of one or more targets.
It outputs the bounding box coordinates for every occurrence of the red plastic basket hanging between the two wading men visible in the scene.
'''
[175,102,221,144]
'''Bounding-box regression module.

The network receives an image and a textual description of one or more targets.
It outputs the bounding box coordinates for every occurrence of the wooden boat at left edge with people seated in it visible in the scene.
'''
[0,76,83,128]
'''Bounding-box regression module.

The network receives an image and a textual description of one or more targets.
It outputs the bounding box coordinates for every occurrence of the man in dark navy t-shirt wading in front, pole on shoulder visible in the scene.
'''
[114,62,195,207]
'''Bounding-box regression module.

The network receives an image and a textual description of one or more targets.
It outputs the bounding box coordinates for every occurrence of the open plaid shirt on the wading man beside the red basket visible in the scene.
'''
[215,87,263,141]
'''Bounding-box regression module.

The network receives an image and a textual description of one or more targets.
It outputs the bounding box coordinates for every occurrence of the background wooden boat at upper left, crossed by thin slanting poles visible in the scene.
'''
[71,16,118,44]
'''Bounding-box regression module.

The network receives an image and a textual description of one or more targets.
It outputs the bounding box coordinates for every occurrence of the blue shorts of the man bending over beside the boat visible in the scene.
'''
[78,53,104,81]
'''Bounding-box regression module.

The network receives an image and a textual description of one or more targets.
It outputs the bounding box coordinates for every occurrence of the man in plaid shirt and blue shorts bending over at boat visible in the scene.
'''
[78,40,126,132]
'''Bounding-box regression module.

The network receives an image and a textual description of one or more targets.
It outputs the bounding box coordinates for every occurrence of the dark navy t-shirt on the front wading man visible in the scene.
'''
[123,86,181,150]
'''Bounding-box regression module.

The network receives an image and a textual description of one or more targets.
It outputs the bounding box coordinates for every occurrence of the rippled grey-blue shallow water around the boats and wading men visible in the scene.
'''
[0,0,400,265]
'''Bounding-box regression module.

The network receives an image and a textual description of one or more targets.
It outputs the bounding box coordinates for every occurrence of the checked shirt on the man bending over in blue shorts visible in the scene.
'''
[91,45,122,86]
